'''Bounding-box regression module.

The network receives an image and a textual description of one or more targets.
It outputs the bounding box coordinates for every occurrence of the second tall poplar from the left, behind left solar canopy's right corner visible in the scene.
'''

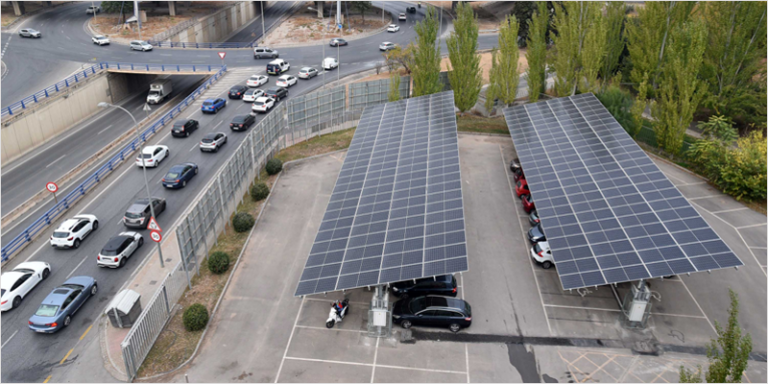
[446,3,483,113]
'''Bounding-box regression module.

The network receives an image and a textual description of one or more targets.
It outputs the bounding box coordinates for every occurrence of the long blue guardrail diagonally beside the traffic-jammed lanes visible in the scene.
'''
[2,63,227,262]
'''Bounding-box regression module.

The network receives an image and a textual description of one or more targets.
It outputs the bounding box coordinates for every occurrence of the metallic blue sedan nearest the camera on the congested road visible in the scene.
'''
[28,276,99,333]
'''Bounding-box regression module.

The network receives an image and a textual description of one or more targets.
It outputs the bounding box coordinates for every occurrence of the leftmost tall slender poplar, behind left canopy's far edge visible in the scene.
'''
[411,7,443,96]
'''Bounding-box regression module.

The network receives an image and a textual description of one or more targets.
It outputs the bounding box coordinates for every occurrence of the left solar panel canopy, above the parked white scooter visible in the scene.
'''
[295,91,468,296]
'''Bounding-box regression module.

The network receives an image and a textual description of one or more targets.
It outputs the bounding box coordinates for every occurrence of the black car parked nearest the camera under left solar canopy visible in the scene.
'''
[392,296,472,333]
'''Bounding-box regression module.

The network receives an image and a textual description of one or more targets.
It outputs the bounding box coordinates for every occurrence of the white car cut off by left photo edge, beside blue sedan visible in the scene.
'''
[0,261,51,312]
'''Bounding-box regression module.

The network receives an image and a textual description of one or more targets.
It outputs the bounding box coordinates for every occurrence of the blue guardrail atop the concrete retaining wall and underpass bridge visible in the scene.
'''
[2,62,224,117]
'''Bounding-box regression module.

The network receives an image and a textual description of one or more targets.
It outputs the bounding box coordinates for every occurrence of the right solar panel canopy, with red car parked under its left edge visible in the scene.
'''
[504,93,743,289]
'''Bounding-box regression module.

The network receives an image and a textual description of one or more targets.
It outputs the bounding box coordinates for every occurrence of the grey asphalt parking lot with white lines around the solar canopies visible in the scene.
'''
[170,134,766,382]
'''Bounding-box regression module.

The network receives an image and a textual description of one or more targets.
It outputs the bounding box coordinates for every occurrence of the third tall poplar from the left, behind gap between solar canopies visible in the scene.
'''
[485,15,520,111]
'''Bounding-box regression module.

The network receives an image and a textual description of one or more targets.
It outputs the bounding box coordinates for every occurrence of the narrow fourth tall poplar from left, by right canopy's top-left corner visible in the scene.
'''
[525,1,549,103]
